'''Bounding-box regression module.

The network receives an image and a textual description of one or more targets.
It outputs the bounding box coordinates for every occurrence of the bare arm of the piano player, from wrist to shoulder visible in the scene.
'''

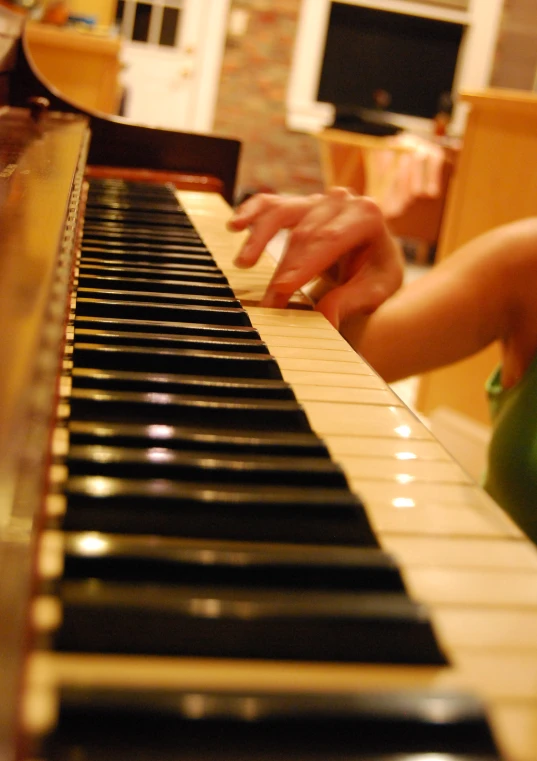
[341,220,537,381]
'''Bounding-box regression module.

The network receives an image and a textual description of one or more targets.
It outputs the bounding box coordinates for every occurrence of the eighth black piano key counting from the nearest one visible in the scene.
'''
[70,367,295,399]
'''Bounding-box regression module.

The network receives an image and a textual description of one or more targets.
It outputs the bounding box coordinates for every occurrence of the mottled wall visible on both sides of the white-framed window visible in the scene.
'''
[214,0,537,202]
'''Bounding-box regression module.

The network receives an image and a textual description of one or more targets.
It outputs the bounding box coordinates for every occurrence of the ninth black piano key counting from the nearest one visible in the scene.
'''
[72,342,281,380]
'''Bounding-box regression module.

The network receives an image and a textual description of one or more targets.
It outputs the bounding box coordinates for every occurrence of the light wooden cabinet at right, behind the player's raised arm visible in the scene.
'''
[417,89,537,423]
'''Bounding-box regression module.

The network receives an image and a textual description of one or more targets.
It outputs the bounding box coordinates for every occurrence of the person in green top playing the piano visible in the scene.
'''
[229,188,537,543]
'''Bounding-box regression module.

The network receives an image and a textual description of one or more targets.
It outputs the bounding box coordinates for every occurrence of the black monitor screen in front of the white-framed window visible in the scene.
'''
[317,3,465,119]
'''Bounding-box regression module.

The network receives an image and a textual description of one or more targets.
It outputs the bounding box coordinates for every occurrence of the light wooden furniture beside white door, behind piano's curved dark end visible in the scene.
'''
[26,22,121,114]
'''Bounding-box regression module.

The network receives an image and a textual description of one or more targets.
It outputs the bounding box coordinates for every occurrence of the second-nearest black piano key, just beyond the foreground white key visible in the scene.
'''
[54,577,445,664]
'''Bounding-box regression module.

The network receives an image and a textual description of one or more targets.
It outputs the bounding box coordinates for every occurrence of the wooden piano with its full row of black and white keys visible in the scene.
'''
[0,10,537,761]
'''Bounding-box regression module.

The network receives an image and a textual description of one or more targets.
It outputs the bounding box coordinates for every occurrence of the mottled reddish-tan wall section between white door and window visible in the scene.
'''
[214,0,322,199]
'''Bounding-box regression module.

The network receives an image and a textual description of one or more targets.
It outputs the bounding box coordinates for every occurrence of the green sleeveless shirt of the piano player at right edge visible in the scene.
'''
[484,356,537,543]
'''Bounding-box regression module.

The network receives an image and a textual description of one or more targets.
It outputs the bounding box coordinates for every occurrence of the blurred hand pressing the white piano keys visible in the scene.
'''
[228,188,403,328]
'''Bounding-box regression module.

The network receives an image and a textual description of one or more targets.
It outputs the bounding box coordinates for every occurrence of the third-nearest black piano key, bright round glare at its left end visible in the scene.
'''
[59,532,404,592]
